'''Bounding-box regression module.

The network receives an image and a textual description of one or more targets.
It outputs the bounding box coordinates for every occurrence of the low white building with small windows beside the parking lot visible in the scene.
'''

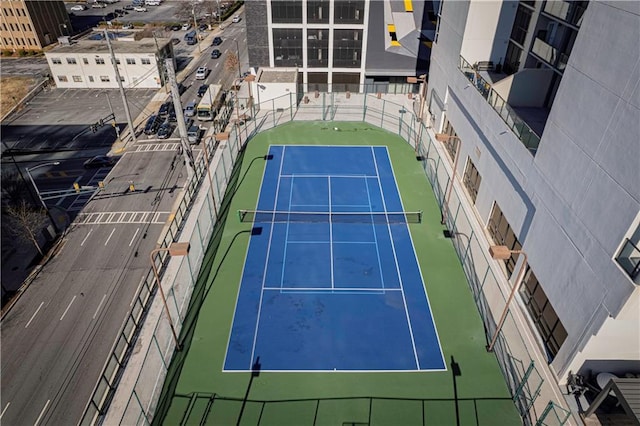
[45,36,175,89]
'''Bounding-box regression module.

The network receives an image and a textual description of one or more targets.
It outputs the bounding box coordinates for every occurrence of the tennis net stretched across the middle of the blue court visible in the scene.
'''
[238,210,422,224]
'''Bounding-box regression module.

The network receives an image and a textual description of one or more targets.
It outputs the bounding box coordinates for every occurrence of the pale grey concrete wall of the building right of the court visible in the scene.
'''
[429,1,640,381]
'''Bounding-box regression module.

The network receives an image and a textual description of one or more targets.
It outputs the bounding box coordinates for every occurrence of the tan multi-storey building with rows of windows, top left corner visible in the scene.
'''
[0,0,72,52]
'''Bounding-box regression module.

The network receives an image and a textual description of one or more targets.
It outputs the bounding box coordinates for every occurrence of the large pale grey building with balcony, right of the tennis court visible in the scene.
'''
[427,0,640,396]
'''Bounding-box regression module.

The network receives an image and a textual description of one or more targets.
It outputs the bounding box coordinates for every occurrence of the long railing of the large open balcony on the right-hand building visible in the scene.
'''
[458,56,540,155]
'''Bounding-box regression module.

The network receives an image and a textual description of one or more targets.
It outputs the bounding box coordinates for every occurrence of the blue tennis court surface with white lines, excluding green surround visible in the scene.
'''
[224,145,446,371]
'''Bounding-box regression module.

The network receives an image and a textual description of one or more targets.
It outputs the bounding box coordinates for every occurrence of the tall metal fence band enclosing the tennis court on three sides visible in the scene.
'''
[89,93,569,425]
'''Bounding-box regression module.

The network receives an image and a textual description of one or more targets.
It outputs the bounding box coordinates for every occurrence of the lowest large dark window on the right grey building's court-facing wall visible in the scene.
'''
[520,268,567,361]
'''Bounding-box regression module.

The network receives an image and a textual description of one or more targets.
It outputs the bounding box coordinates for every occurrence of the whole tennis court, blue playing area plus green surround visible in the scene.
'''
[153,122,521,426]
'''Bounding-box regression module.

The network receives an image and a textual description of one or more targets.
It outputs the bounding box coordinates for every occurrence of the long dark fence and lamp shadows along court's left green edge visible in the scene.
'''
[152,149,273,425]
